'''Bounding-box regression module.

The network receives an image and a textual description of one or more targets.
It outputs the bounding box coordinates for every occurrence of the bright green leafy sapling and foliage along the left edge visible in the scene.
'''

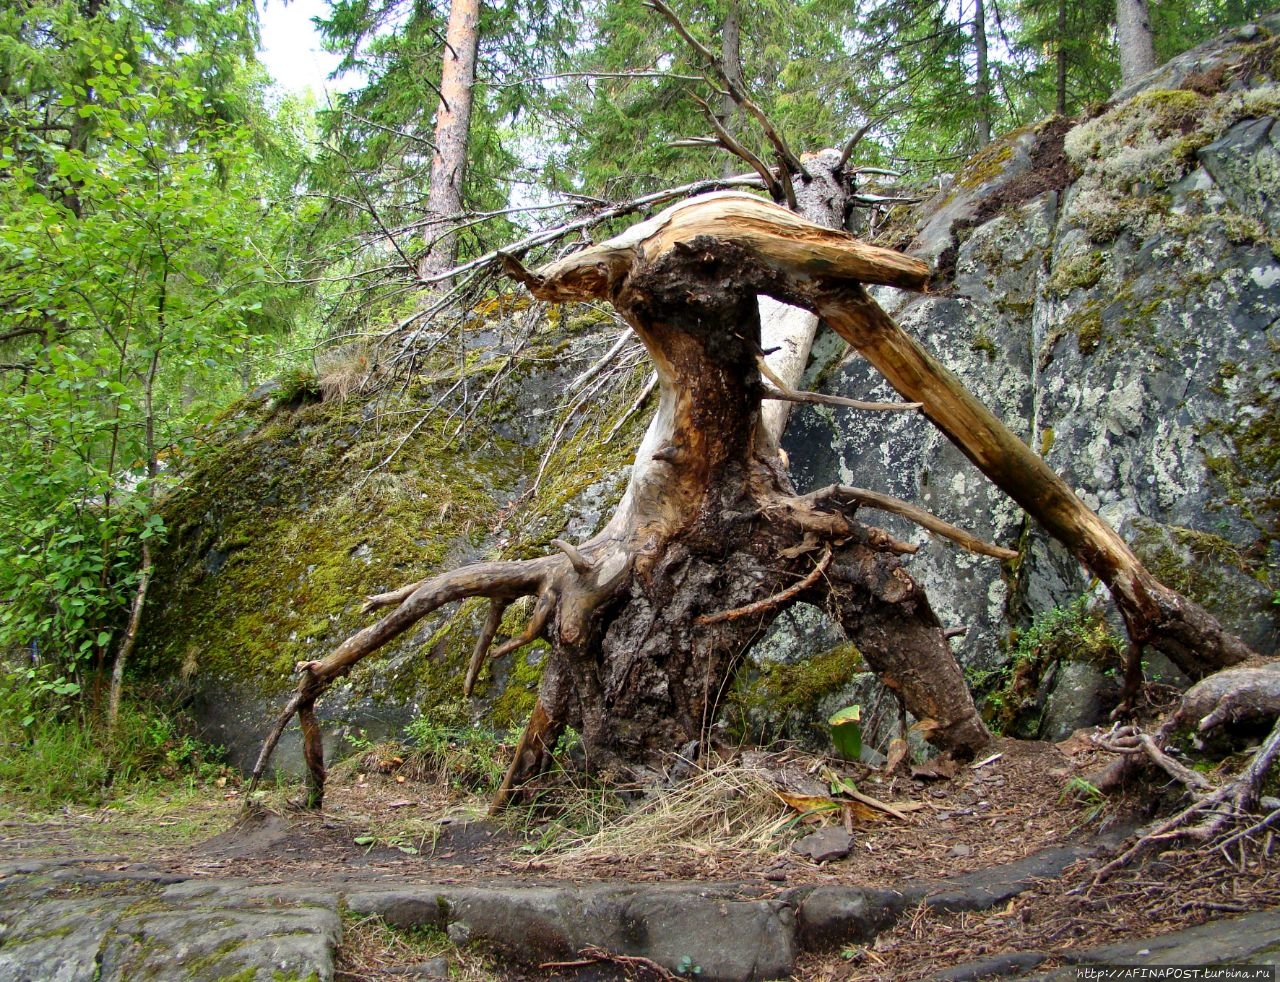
[0,0,303,768]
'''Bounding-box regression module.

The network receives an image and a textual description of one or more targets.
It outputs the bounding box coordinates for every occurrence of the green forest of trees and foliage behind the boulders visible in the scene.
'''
[0,0,1268,800]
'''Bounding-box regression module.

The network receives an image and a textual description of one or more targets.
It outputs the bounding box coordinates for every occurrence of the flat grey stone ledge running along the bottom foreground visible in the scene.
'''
[0,849,1280,982]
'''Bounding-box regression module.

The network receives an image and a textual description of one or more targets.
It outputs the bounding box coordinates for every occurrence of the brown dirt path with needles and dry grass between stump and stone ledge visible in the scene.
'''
[0,740,1280,979]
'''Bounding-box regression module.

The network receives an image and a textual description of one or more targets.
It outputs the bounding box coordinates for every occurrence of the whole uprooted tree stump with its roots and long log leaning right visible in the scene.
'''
[244,192,1256,807]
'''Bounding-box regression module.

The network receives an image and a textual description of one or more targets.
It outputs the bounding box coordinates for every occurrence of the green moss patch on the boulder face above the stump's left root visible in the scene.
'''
[132,389,520,691]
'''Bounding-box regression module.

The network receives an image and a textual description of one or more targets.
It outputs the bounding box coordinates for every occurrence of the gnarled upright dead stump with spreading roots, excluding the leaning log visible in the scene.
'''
[256,195,1011,804]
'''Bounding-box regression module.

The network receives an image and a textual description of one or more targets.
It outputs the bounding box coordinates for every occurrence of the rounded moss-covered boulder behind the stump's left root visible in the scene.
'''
[136,310,645,769]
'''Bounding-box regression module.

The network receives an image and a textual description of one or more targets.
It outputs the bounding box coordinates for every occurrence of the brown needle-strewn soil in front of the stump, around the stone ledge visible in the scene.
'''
[0,734,1280,981]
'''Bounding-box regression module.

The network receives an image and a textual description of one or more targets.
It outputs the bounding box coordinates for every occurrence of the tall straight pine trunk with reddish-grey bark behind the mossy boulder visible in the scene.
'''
[417,0,480,279]
